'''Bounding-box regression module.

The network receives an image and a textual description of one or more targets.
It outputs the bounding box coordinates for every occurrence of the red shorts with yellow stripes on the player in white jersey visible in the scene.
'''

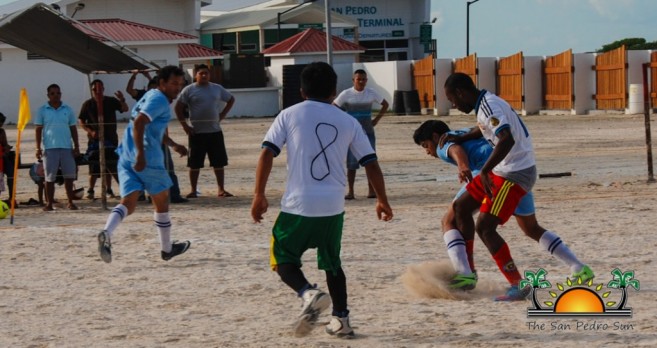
[465,172,527,225]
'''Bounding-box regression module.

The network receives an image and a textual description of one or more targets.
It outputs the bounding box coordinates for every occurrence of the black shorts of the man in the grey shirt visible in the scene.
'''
[187,132,228,169]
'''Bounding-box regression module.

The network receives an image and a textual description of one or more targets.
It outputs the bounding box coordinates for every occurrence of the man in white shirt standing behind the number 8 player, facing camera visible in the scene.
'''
[333,69,388,199]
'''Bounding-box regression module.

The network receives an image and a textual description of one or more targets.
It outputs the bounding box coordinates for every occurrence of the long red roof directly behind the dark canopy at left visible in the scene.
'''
[74,18,197,43]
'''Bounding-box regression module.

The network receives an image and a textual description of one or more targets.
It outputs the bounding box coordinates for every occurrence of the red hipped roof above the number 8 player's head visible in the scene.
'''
[262,28,365,55]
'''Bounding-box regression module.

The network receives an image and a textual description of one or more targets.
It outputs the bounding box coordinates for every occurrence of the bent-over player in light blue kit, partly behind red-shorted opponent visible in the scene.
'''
[413,120,594,300]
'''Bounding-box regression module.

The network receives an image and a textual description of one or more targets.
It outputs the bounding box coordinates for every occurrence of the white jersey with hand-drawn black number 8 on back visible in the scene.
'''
[262,100,376,217]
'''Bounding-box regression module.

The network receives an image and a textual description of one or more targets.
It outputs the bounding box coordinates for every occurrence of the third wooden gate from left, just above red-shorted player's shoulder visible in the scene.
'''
[497,51,524,110]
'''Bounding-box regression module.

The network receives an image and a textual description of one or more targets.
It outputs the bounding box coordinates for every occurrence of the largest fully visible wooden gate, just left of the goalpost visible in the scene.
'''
[593,46,627,110]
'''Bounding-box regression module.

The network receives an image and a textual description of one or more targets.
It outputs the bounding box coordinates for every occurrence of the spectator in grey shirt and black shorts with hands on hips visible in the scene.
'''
[175,64,235,198]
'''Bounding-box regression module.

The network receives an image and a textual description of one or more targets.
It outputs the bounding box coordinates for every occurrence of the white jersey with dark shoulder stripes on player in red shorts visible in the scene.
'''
[475,90,536,176]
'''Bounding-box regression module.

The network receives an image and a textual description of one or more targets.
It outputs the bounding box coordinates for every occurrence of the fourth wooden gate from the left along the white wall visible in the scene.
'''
[544,50,574,110]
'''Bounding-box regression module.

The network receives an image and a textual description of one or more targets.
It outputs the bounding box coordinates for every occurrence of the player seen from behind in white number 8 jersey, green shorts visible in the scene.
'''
[251,62,392,338]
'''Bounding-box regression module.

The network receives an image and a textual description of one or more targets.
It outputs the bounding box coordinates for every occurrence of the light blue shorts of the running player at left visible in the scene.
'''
[117,158,173,197]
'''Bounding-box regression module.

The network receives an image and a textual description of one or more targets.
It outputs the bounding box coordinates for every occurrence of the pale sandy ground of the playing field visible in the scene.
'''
[0,115,657,347]
